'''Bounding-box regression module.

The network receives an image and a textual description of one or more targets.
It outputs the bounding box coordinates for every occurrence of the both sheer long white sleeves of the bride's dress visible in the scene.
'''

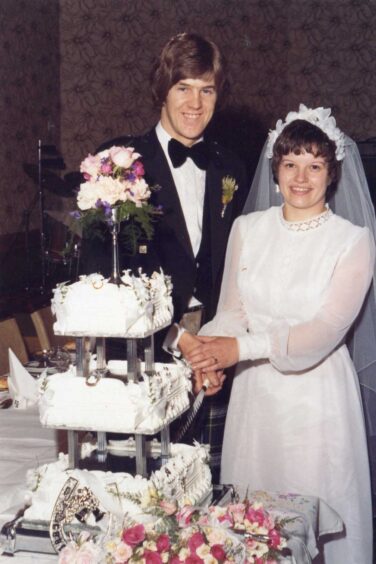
[200,214,375,372]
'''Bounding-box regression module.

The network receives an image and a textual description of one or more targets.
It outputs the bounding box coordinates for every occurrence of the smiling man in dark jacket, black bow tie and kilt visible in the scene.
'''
[88,33,249,480]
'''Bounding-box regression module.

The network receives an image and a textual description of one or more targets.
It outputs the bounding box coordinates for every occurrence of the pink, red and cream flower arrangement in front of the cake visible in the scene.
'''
[59,489,288,564]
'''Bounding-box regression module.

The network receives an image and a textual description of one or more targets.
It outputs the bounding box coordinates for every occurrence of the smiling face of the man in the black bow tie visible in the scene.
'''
[161,76,217,147]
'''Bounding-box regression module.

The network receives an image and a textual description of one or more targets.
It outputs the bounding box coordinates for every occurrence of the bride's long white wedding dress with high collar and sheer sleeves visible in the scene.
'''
[200,207,375,564]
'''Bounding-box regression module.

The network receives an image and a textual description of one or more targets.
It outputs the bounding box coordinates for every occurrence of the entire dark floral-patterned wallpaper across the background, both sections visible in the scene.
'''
[0,0,376,240]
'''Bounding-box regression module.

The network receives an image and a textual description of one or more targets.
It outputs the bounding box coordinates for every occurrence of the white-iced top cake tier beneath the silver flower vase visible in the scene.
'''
[51,270,173,338]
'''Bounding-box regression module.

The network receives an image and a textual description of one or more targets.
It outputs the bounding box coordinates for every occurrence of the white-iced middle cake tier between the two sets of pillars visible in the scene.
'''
[39,362,191,434]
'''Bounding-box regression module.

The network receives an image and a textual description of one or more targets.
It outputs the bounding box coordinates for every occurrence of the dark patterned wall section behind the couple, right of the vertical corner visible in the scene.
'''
[60,0,376,172]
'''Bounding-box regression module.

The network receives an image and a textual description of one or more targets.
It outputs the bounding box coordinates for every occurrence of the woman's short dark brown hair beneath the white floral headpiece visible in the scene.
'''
[272,119,341,199]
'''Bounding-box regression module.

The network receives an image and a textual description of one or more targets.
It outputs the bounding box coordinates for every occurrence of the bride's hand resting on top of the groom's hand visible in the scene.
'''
[187,336,239,373]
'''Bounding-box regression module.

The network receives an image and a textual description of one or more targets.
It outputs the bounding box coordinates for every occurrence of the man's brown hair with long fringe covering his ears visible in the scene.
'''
[152,33,227,108]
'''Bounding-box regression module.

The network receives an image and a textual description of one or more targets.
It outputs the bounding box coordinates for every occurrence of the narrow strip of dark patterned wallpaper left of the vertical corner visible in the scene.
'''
[0,0,60,235]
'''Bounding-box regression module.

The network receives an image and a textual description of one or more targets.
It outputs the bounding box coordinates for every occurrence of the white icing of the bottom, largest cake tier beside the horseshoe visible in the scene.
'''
[24,445,212,522]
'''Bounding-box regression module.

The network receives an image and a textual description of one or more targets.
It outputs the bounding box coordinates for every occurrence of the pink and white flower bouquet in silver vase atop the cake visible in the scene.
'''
[73,146,160,254]
